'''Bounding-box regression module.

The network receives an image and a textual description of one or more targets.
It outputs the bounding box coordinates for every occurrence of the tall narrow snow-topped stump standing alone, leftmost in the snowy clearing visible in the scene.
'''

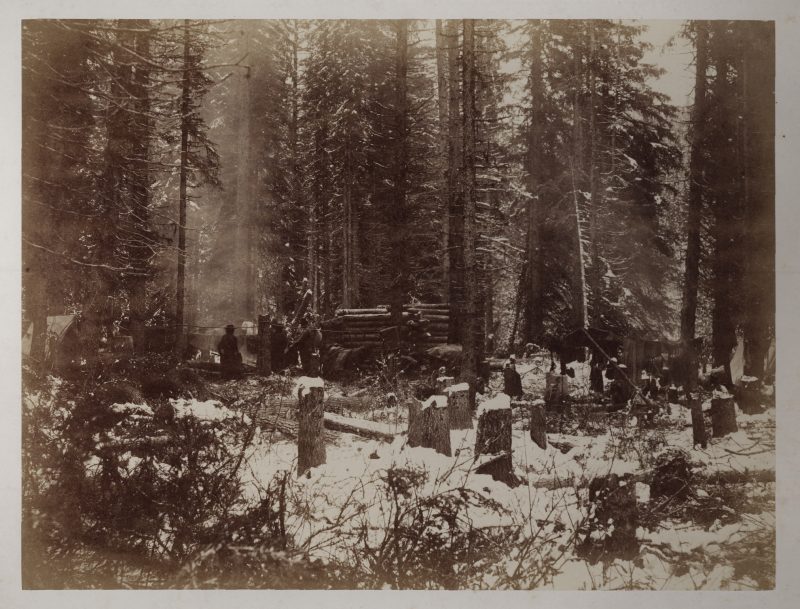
[297,376,325,476]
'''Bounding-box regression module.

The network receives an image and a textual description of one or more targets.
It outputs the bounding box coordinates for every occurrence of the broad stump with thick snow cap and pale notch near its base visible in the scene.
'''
[475,393,520,487]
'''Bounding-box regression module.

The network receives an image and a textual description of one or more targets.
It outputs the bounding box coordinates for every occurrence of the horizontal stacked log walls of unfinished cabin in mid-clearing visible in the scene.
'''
[322,304,450,348]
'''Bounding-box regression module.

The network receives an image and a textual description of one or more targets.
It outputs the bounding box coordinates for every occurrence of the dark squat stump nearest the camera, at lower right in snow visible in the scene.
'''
[578,474,639,563]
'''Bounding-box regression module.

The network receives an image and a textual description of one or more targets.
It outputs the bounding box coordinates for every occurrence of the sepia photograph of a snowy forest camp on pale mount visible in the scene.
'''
[12,0,796,598]
